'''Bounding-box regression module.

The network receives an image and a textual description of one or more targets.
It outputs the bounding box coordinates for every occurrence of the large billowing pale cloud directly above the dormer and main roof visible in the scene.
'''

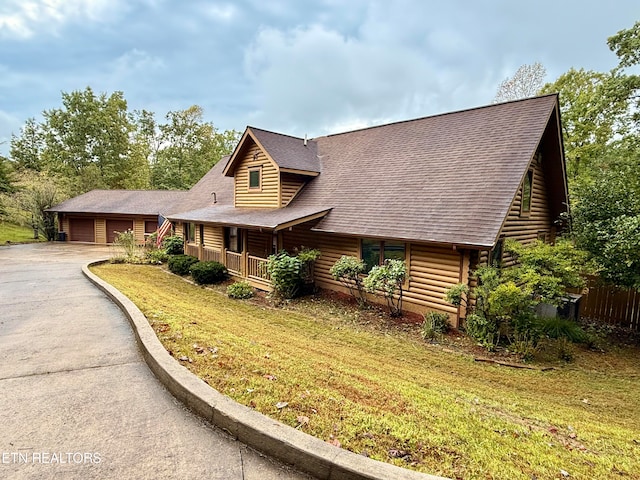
[244,21,480,134]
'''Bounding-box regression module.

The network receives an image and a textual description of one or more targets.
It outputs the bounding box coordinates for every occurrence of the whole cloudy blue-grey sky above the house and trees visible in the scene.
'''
[0,0,640,154]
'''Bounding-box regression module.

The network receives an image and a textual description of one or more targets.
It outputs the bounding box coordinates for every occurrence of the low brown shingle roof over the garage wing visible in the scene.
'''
[49,190,187,215]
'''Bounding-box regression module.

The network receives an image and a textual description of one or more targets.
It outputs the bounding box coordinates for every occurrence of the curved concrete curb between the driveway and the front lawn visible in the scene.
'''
[82,261,447,480]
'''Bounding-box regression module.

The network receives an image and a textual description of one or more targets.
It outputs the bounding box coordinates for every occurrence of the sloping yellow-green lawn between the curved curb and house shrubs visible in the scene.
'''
[93,264,640,480]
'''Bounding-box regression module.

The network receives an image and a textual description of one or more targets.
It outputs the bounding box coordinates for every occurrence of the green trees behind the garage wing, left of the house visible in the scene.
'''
[0,87,240,236]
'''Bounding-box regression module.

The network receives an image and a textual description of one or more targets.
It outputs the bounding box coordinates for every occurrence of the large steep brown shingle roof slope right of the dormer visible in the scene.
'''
[290,95,557,246]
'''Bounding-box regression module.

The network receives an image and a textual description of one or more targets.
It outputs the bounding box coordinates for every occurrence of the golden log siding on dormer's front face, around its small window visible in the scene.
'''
[234,144,281,208]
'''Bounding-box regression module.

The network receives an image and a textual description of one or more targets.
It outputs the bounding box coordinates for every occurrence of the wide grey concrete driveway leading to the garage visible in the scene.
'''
[0,243,309,480]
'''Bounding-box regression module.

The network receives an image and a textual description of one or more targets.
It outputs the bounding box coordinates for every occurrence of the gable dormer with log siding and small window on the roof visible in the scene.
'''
[224,127,320,208]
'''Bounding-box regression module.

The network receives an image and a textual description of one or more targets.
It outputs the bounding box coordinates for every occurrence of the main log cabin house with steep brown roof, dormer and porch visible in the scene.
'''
[54,94,568,326]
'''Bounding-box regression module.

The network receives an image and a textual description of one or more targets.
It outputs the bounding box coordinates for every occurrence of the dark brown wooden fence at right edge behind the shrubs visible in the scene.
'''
[580,279,640,331]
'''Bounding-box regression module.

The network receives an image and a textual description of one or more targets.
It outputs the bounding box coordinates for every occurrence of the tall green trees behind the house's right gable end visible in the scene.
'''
[495,22,640,289]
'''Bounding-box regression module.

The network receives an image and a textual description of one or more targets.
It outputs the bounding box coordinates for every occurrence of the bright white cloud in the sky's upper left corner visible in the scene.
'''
[0,0,124,39]
